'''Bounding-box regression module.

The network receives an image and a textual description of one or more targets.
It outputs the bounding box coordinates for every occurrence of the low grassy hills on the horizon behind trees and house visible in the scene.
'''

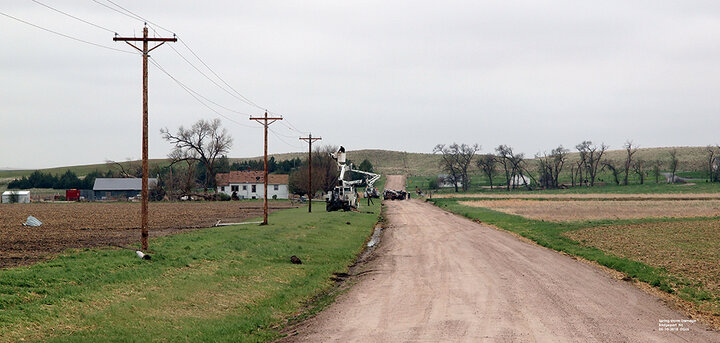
[0,147,707,183]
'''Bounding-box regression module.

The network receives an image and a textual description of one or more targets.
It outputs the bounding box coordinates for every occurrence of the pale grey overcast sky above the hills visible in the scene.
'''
[0,0,720,168]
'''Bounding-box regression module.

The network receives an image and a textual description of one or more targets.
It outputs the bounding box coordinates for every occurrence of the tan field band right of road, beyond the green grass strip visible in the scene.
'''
[459,199,720,222]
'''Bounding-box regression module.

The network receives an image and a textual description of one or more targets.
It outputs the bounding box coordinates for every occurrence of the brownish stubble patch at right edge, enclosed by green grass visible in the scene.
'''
[565,220,720,322]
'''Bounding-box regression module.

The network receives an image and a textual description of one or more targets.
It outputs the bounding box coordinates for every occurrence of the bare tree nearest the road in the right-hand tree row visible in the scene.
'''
[433,143,480,192]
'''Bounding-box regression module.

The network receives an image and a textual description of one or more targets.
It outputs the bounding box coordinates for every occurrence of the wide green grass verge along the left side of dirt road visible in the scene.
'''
[0,201,380,342]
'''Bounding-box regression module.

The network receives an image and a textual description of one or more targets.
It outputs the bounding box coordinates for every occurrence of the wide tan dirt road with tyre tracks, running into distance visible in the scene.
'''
[285,178,720,342]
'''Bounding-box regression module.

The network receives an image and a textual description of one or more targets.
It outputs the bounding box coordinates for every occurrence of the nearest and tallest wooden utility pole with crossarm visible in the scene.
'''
[113,26,177,251]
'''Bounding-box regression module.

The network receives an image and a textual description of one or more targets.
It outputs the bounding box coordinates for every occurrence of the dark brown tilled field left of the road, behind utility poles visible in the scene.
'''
[0,201,291,268]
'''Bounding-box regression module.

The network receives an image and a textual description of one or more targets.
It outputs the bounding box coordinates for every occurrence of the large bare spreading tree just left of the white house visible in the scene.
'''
[160,118,232,192]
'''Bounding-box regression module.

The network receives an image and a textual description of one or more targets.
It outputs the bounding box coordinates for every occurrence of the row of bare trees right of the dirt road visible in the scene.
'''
[431,140,720,192]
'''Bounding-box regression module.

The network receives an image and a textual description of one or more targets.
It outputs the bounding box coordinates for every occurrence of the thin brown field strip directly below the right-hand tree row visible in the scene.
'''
[433,193,720,200]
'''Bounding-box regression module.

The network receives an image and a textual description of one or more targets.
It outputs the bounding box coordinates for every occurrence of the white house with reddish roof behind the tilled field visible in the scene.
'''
[215,171,290,199]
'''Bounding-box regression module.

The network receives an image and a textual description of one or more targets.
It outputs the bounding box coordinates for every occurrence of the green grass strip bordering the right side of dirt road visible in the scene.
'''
[428,198,720,325]
